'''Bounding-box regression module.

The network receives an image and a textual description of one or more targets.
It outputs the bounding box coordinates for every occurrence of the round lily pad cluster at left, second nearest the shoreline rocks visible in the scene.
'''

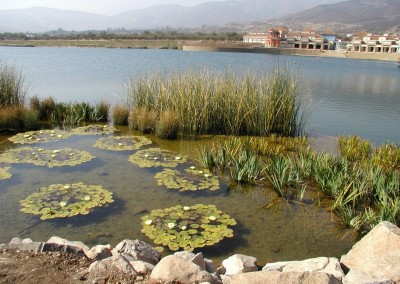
[20,182,114,220]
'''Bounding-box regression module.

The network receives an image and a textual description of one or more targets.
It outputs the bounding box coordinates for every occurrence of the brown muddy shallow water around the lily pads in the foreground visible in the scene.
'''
[0,128,357,263]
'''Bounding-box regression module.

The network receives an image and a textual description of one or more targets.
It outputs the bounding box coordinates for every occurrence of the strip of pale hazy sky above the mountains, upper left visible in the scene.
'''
[0,0,228,15]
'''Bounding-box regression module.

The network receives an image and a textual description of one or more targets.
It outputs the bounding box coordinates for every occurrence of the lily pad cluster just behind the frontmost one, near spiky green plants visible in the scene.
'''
[155,166,219,191]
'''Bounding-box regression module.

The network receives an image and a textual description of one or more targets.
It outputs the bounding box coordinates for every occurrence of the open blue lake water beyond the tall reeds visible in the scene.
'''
[0,47,400,144]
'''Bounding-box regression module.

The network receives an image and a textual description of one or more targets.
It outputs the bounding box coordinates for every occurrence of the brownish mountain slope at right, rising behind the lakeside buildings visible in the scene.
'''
[270,0,400,33]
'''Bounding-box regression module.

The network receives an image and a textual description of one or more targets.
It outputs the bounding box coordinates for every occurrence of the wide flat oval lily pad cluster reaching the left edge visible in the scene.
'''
[0,147,94,168]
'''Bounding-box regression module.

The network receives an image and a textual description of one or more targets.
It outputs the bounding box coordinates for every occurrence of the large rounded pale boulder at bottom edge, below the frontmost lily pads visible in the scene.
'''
[150,255,221,284]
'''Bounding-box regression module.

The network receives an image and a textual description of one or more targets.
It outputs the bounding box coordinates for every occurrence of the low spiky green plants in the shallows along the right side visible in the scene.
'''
[199,136,400,233]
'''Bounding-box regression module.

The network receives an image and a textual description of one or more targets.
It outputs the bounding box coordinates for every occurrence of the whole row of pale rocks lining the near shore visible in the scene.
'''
[0,222,400,284]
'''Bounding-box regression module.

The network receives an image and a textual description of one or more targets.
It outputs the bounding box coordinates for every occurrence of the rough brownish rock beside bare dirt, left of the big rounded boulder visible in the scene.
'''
[89,255,137,278]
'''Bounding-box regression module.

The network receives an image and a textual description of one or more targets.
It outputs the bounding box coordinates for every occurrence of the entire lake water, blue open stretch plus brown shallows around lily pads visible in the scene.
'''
[0,47,400,263]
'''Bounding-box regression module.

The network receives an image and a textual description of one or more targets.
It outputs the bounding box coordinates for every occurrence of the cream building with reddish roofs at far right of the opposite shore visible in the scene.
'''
[347,33,400,53]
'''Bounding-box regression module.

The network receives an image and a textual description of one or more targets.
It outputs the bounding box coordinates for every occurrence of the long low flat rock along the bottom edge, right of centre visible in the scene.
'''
[229,270,341,284]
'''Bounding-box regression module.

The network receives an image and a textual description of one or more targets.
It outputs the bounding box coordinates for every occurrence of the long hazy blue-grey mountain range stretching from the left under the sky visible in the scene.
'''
[0,0,340,32]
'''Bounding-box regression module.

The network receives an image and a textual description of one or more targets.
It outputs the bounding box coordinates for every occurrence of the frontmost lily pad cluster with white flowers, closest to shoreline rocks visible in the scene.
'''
[142,204,236,251]
